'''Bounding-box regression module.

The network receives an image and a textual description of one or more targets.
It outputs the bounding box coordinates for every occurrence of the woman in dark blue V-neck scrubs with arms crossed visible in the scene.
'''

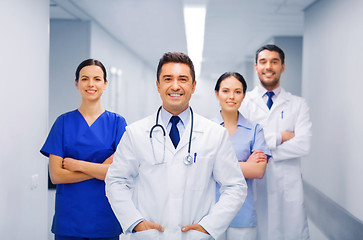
[40,59,126,240]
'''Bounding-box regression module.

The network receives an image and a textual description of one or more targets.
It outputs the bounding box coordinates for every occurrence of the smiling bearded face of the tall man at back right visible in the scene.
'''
[255,50,285,91]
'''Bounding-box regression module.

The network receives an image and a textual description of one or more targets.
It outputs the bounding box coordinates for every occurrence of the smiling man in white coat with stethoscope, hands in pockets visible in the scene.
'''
[106,52,247,240]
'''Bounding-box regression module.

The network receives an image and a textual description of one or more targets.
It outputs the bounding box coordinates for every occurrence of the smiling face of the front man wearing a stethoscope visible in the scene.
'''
[156,62,196,115]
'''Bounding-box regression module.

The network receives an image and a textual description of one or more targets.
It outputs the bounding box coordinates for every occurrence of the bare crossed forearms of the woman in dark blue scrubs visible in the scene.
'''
[49,154,113,184]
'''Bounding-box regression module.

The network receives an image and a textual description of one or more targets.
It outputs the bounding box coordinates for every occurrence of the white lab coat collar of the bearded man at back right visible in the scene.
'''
[249,86,291,112]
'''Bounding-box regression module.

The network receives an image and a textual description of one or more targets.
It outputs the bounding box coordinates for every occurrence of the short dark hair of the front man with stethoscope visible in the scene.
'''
[156,52,195,82]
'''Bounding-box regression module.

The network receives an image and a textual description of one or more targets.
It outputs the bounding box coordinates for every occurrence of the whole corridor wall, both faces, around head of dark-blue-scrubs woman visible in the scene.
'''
[50,19,161,124]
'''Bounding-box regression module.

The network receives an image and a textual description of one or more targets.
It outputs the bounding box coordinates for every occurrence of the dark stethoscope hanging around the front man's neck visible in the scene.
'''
[150,106,194,165]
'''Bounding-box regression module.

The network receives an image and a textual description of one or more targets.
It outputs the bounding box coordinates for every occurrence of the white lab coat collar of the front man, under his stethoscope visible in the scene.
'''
[146,106,204,154]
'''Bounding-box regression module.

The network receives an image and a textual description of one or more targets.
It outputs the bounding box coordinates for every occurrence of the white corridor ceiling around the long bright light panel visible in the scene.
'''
[50,0,316,81]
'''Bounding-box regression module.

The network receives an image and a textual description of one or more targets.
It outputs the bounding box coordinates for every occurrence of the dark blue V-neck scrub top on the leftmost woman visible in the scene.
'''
[40,110,126,238]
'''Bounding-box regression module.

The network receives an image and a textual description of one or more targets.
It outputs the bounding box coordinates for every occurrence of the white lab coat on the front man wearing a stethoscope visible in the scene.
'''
[106,110,247,240]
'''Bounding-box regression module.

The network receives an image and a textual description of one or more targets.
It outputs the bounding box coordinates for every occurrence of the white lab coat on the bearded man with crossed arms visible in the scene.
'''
[240,87,312,240]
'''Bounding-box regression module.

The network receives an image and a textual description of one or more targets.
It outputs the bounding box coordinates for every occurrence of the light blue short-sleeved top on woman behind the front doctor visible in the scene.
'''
[215,113,271,228]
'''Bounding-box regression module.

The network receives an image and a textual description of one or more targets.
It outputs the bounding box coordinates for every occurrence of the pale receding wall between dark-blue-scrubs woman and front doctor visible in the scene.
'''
[90,23,159,124]
